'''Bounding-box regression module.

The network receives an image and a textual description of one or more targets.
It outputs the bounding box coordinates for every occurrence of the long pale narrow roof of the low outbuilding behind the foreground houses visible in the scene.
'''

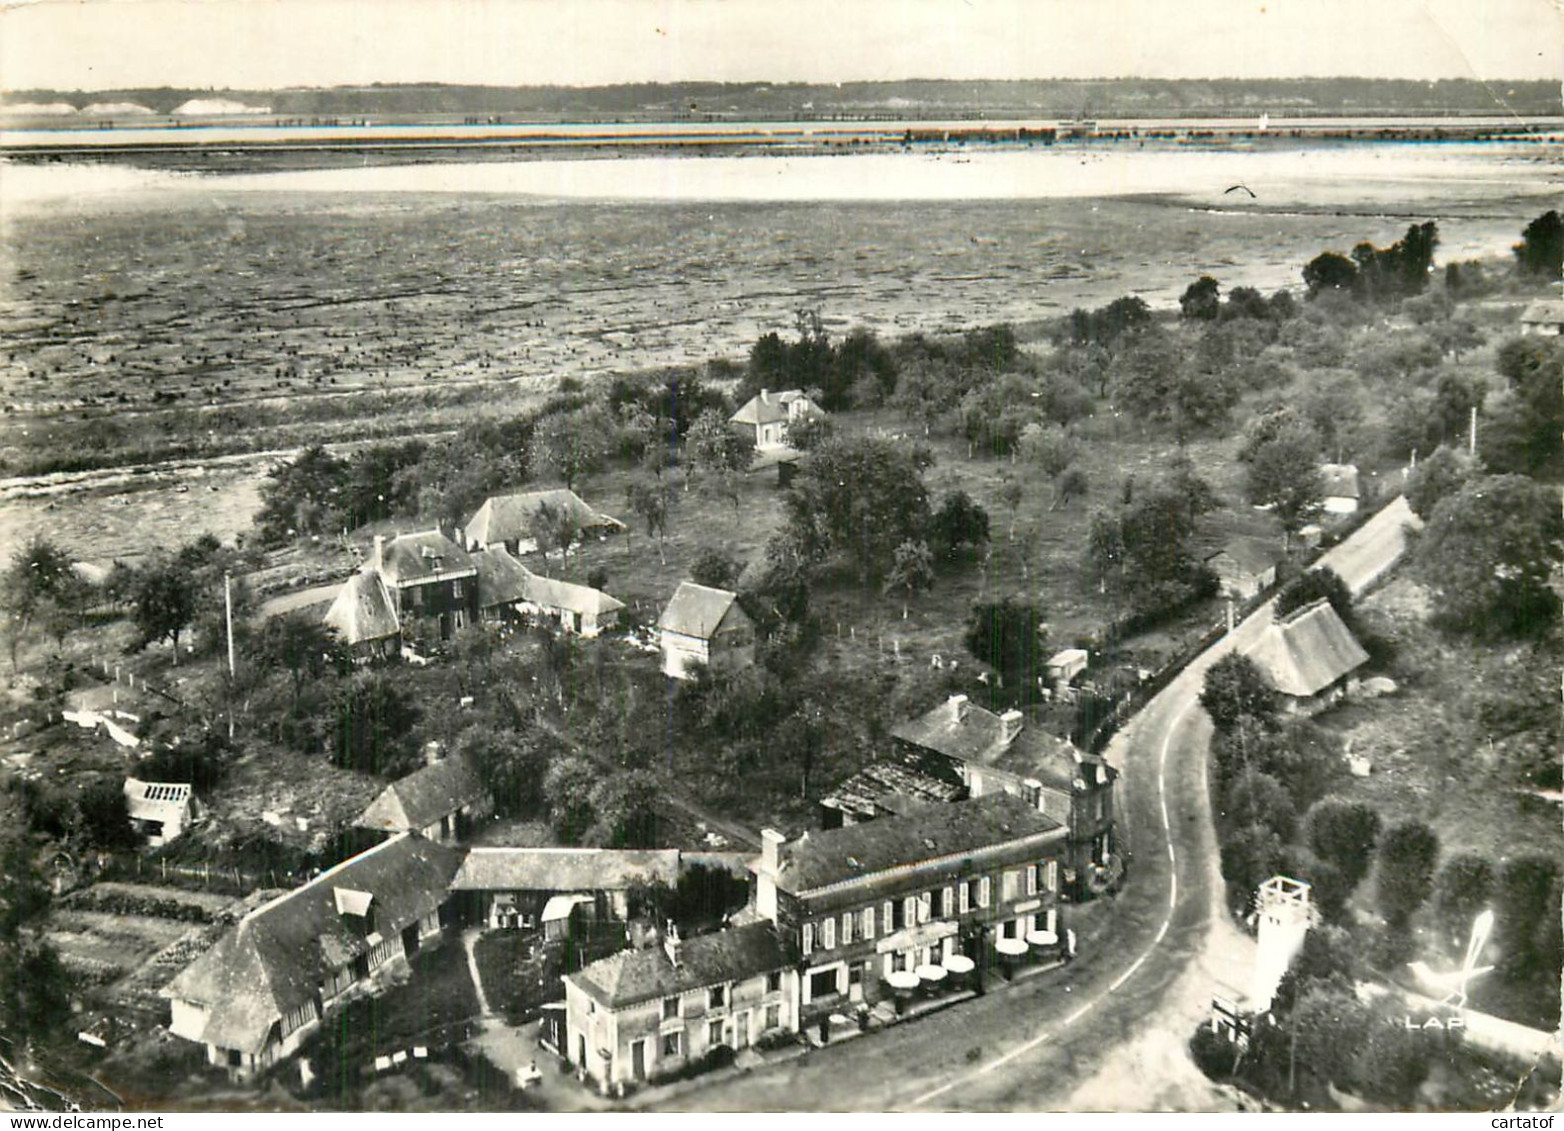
[450,848,679,892]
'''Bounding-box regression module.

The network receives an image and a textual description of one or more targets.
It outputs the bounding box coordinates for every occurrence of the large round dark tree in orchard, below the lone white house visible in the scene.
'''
[787,436,929,583]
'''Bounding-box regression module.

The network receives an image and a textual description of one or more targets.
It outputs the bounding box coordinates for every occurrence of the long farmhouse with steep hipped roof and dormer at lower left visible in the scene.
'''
[163,834,458,1078]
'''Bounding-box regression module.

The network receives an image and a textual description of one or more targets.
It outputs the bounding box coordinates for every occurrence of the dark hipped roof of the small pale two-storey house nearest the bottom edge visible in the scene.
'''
[566,923,793,1009]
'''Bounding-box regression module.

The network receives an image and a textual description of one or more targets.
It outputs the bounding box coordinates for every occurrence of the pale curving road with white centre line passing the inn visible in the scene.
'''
[653,499,1411,1111]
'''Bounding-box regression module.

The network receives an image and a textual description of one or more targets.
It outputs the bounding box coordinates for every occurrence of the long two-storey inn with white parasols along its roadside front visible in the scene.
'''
[754,792,1067,1025]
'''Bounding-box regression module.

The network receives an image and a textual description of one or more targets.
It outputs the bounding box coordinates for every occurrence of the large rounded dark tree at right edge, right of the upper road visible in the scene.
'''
[1412,476,1564,638]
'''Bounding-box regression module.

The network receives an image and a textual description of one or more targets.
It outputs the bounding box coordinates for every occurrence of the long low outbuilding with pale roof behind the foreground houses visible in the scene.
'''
[450,848,680,928]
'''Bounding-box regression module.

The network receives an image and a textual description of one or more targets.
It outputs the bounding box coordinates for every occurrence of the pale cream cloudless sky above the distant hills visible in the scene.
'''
[0,0,1564,91]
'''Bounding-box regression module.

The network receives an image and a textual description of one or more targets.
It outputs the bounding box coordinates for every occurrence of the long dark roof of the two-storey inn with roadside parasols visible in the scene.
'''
[776,793,1064,895]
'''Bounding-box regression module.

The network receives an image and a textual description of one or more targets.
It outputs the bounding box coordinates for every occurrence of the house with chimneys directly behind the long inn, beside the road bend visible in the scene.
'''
[891,695,1120,898]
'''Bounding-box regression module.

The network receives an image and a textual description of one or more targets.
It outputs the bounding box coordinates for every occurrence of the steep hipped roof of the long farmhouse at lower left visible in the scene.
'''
[163,834,458,1053]
